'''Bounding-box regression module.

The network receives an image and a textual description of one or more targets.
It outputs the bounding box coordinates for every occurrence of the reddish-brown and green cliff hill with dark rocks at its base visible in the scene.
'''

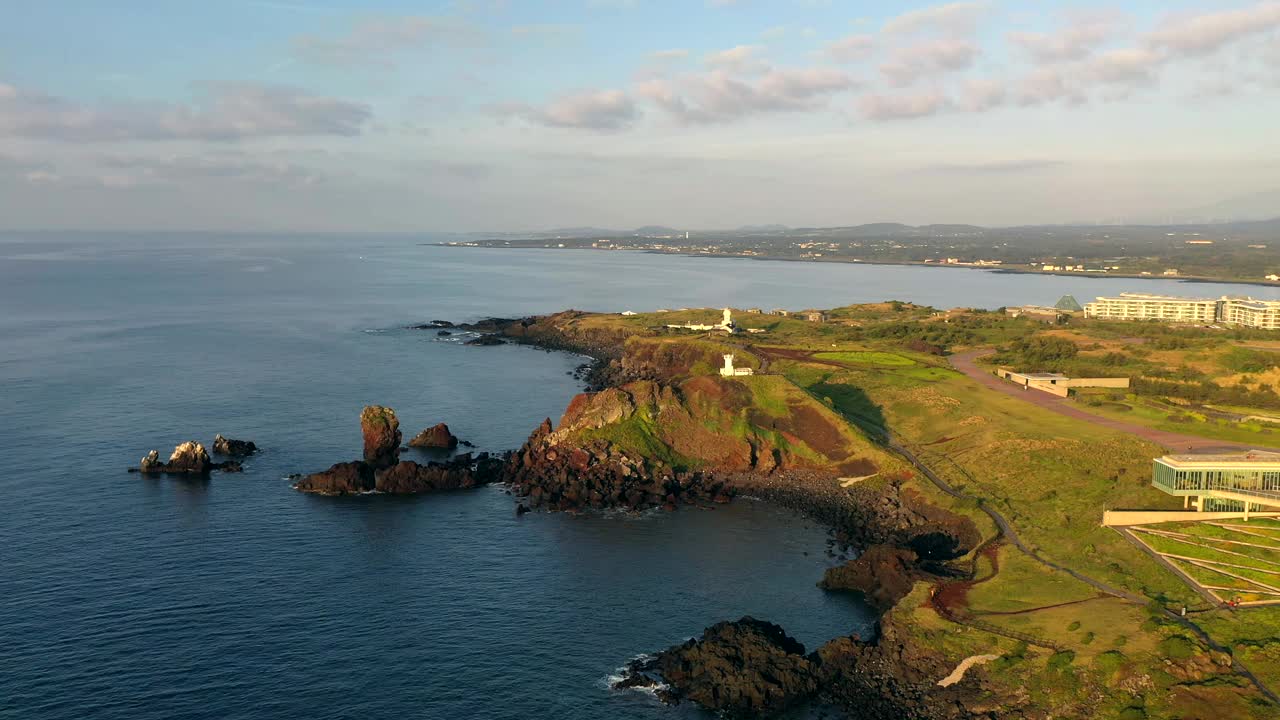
[507,375,901,509]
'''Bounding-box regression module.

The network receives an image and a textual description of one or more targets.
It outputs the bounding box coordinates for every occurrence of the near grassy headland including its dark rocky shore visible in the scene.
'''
[456,302,1280,720]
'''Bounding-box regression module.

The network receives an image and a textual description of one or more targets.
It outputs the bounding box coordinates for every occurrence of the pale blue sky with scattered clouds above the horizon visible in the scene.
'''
[0,0,1280,232]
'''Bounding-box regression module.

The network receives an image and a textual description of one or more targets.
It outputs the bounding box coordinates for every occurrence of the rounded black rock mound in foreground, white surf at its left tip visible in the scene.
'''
[614,618,819,717]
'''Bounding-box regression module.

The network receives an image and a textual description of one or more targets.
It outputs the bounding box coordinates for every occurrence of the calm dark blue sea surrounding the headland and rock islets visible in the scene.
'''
[0,234,1277,720]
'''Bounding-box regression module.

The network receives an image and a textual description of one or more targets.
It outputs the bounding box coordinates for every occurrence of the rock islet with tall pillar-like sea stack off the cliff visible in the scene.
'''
[293,405,503,495]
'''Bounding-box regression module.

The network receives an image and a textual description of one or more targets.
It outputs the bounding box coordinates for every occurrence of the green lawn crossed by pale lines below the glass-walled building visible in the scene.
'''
[1124,518,1280,607]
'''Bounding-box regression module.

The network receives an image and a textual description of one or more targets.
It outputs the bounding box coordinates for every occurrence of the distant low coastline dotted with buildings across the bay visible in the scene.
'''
[438,218,1280,287]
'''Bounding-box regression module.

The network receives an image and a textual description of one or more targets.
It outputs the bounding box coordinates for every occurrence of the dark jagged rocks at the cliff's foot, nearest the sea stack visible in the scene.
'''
[506,419,735,510]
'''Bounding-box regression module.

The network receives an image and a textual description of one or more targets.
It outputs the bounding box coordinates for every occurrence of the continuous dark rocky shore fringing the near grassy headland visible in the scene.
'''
[445,311,987,720]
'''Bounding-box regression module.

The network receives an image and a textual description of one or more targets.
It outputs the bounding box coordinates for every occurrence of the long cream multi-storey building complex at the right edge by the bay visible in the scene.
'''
[1084,292,1280,329]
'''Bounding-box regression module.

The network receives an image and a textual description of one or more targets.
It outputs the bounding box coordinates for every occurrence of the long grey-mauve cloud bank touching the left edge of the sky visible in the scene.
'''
[0,83,372,142]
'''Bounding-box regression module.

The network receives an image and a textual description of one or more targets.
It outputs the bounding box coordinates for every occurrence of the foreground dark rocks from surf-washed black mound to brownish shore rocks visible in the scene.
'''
[613,618,977,720]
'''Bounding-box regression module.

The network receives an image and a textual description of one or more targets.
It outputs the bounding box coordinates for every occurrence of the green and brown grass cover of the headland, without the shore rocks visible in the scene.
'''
[481,302,1280,717]
